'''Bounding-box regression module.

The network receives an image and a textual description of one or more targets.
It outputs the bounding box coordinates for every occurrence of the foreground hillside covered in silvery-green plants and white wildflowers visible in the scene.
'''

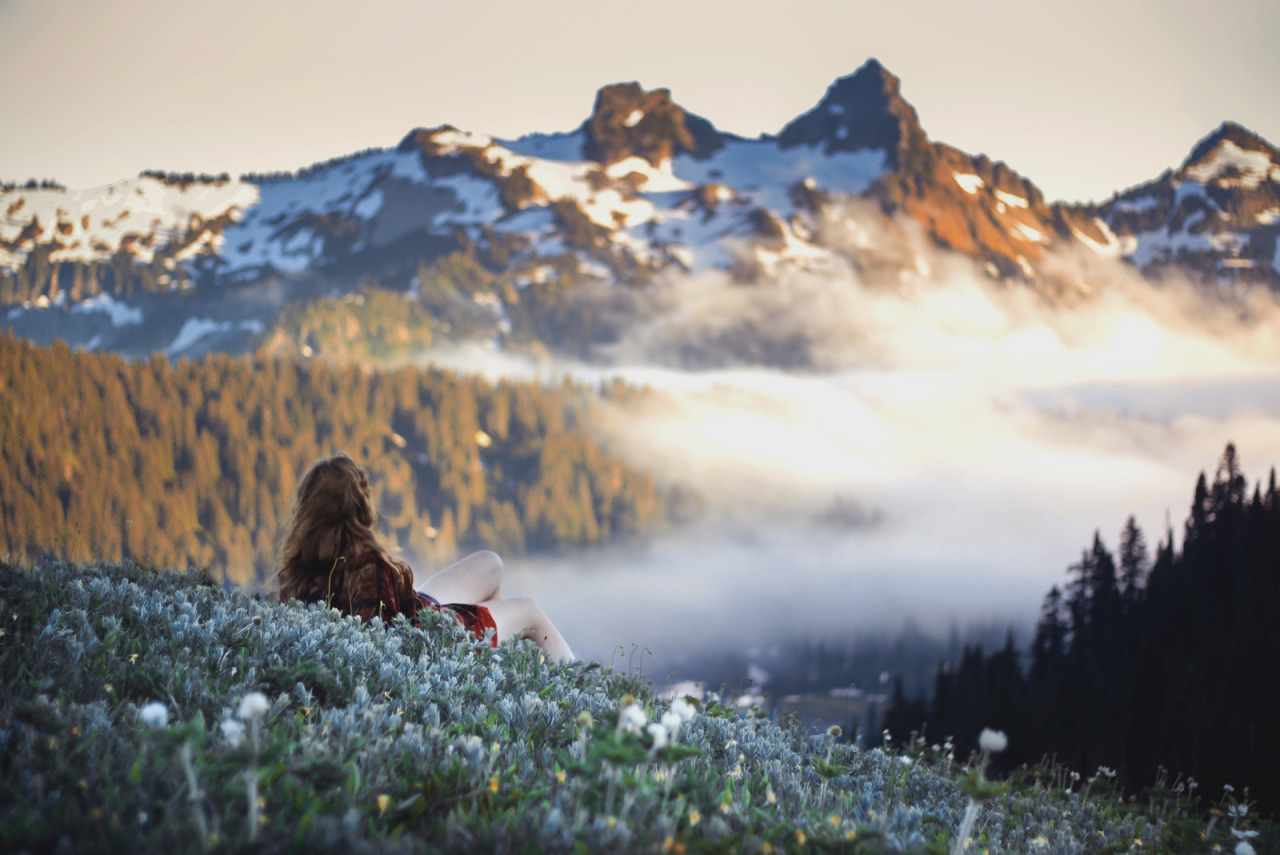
[0,563,1267,854]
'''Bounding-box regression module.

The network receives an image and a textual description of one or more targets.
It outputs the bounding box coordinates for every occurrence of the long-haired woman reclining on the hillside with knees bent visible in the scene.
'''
[276,452,573,660]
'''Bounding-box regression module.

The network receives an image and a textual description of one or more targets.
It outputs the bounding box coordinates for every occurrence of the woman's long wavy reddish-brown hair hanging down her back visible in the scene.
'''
[275,452,387,603]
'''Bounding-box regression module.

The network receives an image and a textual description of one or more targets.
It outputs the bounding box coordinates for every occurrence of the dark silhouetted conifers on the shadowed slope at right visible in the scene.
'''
[886,445,1280,810]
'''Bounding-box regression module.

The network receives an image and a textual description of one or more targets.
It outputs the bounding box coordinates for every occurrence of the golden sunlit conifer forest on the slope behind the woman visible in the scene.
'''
[0,335,664,586]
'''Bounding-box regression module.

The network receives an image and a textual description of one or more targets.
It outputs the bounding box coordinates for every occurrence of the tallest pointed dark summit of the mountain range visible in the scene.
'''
[778,59,928,168]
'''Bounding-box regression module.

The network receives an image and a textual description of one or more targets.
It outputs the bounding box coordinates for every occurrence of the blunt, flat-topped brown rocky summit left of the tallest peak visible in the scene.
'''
[581,82,724,166]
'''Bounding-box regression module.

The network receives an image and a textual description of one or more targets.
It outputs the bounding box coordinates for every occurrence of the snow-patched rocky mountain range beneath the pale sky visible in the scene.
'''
[0,60,1280,357]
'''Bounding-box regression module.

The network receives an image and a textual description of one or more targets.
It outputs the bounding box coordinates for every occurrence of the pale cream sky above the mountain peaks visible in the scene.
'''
[0,0,1280,200]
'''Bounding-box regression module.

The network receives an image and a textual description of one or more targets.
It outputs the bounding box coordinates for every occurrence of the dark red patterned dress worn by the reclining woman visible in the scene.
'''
[298,552,498,648]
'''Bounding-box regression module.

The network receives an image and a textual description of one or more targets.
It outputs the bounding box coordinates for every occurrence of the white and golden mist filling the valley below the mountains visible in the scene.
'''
[414,206,1280,696]
